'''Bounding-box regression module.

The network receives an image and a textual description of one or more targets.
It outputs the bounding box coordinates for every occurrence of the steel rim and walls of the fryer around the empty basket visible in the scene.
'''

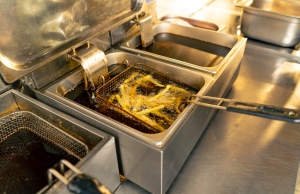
[0,90,120,193]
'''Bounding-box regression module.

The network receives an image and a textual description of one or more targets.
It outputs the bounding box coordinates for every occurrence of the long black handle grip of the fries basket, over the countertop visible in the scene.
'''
[227,100,300,123]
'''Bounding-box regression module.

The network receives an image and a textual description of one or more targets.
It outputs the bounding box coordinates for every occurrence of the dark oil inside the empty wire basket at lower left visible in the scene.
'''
[0,129,78,193]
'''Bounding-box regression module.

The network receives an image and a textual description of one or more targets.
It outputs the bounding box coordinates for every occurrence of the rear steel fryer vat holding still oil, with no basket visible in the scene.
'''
[120,22,246,74]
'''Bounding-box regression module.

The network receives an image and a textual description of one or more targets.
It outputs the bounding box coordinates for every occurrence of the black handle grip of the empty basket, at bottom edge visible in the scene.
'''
[68,174,111,194]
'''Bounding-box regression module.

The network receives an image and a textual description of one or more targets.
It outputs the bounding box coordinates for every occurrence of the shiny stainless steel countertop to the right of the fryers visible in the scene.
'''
[115,0,300,194]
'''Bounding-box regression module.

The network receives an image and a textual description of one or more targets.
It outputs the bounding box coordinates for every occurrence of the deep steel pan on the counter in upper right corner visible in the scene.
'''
[236,0,300,47]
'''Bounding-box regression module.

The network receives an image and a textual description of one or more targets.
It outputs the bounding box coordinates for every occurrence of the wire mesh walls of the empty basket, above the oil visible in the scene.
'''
[0,111,88,168]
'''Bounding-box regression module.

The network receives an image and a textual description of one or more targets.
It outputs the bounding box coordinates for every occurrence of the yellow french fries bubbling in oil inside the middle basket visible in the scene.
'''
[108,72,191,132]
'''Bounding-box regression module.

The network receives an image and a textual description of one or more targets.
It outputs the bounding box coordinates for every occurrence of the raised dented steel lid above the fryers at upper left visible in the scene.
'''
[0,0,146,83]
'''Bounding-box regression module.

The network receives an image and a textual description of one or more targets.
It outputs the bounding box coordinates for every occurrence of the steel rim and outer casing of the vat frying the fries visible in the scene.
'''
[36,47,244,193]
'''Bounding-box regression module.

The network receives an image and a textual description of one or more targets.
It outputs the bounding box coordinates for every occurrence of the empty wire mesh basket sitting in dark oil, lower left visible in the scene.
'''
[0,111,88,193]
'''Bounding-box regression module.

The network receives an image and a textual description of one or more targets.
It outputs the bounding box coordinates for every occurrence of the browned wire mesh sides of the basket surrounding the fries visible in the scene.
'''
[96,63,197,134]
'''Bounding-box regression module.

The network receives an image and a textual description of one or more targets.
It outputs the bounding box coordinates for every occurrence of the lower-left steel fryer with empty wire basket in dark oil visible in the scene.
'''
[0,90,120,193]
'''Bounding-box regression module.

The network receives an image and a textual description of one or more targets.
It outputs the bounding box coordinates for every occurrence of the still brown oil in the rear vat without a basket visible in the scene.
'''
[137,33,230,67]
